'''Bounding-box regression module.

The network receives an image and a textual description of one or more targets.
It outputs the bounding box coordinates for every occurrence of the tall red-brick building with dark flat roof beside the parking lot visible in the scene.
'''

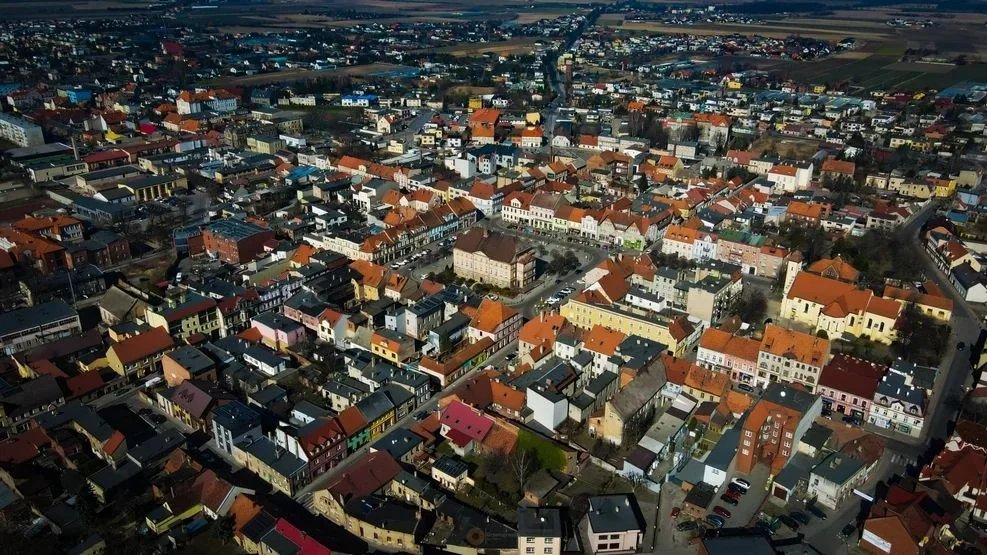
[736,382,822,476]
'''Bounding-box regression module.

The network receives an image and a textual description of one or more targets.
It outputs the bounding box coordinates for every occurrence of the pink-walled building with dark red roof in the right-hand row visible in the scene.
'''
[816,353,888,421]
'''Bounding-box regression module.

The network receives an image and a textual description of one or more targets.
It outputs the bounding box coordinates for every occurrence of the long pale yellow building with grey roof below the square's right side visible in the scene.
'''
[560,292,696,357]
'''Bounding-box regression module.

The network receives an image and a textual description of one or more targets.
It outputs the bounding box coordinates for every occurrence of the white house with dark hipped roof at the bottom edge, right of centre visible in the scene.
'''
[585,494,646,553]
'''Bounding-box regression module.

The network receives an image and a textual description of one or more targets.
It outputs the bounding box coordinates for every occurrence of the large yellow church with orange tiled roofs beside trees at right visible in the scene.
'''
[781,272,902,344]
